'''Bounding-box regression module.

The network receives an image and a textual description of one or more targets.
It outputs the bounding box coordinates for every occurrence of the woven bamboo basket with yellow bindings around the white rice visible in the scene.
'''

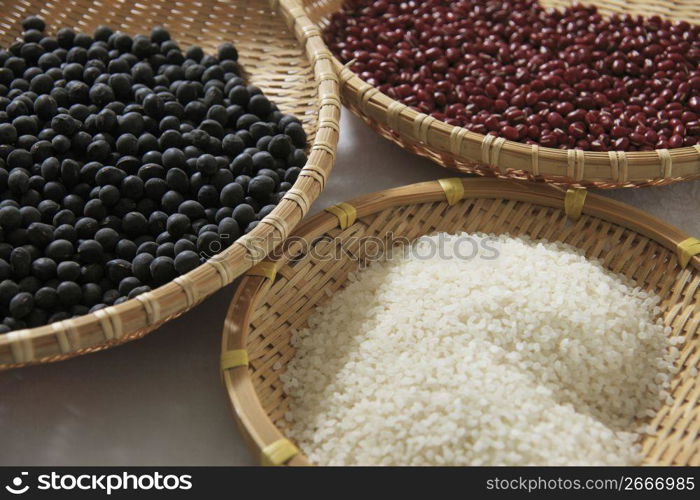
[221,178,700,465]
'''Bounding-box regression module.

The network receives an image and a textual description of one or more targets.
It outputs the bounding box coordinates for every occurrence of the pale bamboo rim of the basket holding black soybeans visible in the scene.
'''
[0,0,340,371]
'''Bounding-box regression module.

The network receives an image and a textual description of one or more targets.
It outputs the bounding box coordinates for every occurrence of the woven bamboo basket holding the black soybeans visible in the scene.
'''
[0,0,340,369]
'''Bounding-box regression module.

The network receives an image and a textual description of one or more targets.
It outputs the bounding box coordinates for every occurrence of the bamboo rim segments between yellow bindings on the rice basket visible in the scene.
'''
[221,178,700,466]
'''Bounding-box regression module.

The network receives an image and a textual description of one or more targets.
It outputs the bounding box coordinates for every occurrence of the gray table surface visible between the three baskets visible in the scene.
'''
[0,110,700,465]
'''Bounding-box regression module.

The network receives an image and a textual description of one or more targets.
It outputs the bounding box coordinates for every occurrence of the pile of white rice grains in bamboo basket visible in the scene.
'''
[278,233,682,465]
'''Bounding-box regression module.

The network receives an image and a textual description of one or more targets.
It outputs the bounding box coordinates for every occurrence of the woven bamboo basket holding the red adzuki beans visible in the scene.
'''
[301,0,700,188]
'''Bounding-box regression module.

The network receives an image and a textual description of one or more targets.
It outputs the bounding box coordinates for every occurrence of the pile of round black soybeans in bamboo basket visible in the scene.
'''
[0,16,306,333]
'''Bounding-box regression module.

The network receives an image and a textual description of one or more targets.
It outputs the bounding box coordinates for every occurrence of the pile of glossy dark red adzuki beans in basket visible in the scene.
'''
[324,0,700,151]
